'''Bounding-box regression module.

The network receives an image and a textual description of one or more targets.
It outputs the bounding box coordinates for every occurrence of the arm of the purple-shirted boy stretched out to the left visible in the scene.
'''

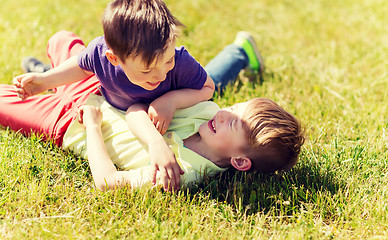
[13,56,93,100]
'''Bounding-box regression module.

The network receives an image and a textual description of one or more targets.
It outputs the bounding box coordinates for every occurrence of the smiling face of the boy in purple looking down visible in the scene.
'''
[117,39,175,91]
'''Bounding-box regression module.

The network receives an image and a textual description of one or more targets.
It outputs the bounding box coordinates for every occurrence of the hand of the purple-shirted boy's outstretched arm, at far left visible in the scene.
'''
[13,73,47,100]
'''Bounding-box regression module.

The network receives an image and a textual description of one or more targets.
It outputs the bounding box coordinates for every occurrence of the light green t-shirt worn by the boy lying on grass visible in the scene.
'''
[62,94,226,188]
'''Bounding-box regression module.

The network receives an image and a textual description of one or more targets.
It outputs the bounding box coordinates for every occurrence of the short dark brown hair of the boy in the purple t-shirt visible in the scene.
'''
[102,0,183,66]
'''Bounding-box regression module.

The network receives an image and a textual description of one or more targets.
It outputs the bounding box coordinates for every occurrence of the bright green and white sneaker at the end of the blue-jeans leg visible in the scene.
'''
[233,32,264,78]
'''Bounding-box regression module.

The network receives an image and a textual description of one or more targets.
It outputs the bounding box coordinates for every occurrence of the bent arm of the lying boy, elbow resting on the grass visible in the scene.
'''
[79,106,154,190]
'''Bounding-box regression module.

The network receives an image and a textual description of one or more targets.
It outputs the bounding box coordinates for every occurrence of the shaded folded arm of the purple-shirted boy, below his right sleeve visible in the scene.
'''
[148,76,215,135]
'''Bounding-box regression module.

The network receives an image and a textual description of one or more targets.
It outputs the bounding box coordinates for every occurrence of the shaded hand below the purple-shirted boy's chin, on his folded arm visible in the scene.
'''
[148,97,176,135]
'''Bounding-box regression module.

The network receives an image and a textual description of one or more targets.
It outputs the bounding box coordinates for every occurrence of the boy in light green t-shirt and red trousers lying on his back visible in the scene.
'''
[0,79,304,190]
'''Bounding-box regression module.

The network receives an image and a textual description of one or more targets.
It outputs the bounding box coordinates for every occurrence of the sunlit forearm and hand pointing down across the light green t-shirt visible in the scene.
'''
[125,103,184,190]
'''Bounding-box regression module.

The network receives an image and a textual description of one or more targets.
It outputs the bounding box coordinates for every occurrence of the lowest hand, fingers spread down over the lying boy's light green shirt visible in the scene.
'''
[149,143,184,191]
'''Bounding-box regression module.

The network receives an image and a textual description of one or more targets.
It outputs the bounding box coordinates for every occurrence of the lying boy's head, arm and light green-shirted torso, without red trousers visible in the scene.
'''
[76,95,304,190]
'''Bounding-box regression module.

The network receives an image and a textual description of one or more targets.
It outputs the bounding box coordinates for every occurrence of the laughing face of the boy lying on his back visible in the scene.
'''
[199,102,249,157]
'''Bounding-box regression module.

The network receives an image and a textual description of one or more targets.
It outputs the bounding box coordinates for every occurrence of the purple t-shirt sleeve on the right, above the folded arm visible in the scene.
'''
[175,47,207,89]
